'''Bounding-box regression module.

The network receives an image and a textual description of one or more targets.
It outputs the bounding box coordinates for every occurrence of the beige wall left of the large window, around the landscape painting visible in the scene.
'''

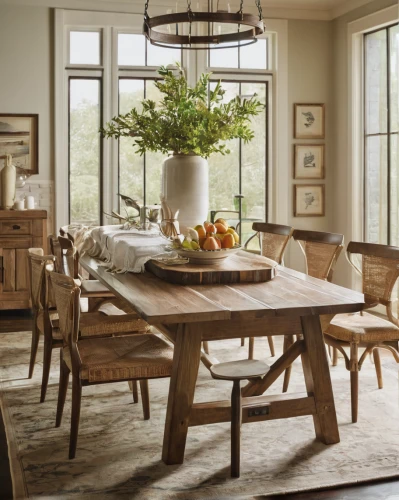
[0,5,54,180]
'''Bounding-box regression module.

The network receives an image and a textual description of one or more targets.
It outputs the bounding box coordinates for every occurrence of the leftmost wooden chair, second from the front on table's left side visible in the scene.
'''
[28,248,148,403]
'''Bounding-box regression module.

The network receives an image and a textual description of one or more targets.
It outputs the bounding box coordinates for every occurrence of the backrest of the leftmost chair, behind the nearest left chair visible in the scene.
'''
[28,248,55,311]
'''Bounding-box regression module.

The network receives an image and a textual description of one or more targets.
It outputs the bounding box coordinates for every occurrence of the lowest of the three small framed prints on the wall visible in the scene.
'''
[294,184,325,217]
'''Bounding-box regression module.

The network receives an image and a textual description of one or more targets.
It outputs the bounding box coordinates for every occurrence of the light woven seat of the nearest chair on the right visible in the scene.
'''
[325,312,399,342]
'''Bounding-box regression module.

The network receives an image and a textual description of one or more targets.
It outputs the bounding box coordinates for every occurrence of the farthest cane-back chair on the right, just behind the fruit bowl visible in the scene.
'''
[241,222,293,359]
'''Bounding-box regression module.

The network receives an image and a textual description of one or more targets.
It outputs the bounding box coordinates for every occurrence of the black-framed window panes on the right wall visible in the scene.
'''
[364,24,399,245]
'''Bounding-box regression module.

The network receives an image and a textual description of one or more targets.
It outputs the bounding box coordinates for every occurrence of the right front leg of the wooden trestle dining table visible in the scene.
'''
[301,316,340,444]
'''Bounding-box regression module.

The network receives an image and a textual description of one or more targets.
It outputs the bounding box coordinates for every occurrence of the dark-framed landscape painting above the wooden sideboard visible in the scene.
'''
[0,113,39,175]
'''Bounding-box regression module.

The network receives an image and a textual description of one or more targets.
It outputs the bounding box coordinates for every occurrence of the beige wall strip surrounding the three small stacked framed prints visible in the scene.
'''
[286,20,334,270]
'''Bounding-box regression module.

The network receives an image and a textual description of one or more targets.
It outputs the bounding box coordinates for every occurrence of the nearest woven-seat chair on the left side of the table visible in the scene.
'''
[47,271,173,459]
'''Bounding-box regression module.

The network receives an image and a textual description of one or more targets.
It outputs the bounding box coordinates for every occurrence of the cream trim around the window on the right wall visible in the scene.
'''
[347,6,398,289]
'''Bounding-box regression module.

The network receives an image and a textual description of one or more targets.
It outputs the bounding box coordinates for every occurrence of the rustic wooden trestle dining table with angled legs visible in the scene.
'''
[81,254,366,464]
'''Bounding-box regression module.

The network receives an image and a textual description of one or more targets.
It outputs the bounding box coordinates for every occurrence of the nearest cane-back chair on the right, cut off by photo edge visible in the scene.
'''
[324,241,399,422]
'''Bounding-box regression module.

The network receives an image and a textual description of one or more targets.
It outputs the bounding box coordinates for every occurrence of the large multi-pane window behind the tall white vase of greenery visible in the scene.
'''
[57,11,272,229]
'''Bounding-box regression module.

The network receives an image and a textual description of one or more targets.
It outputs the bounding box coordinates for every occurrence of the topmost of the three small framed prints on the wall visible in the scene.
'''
[294,104,325,139]
